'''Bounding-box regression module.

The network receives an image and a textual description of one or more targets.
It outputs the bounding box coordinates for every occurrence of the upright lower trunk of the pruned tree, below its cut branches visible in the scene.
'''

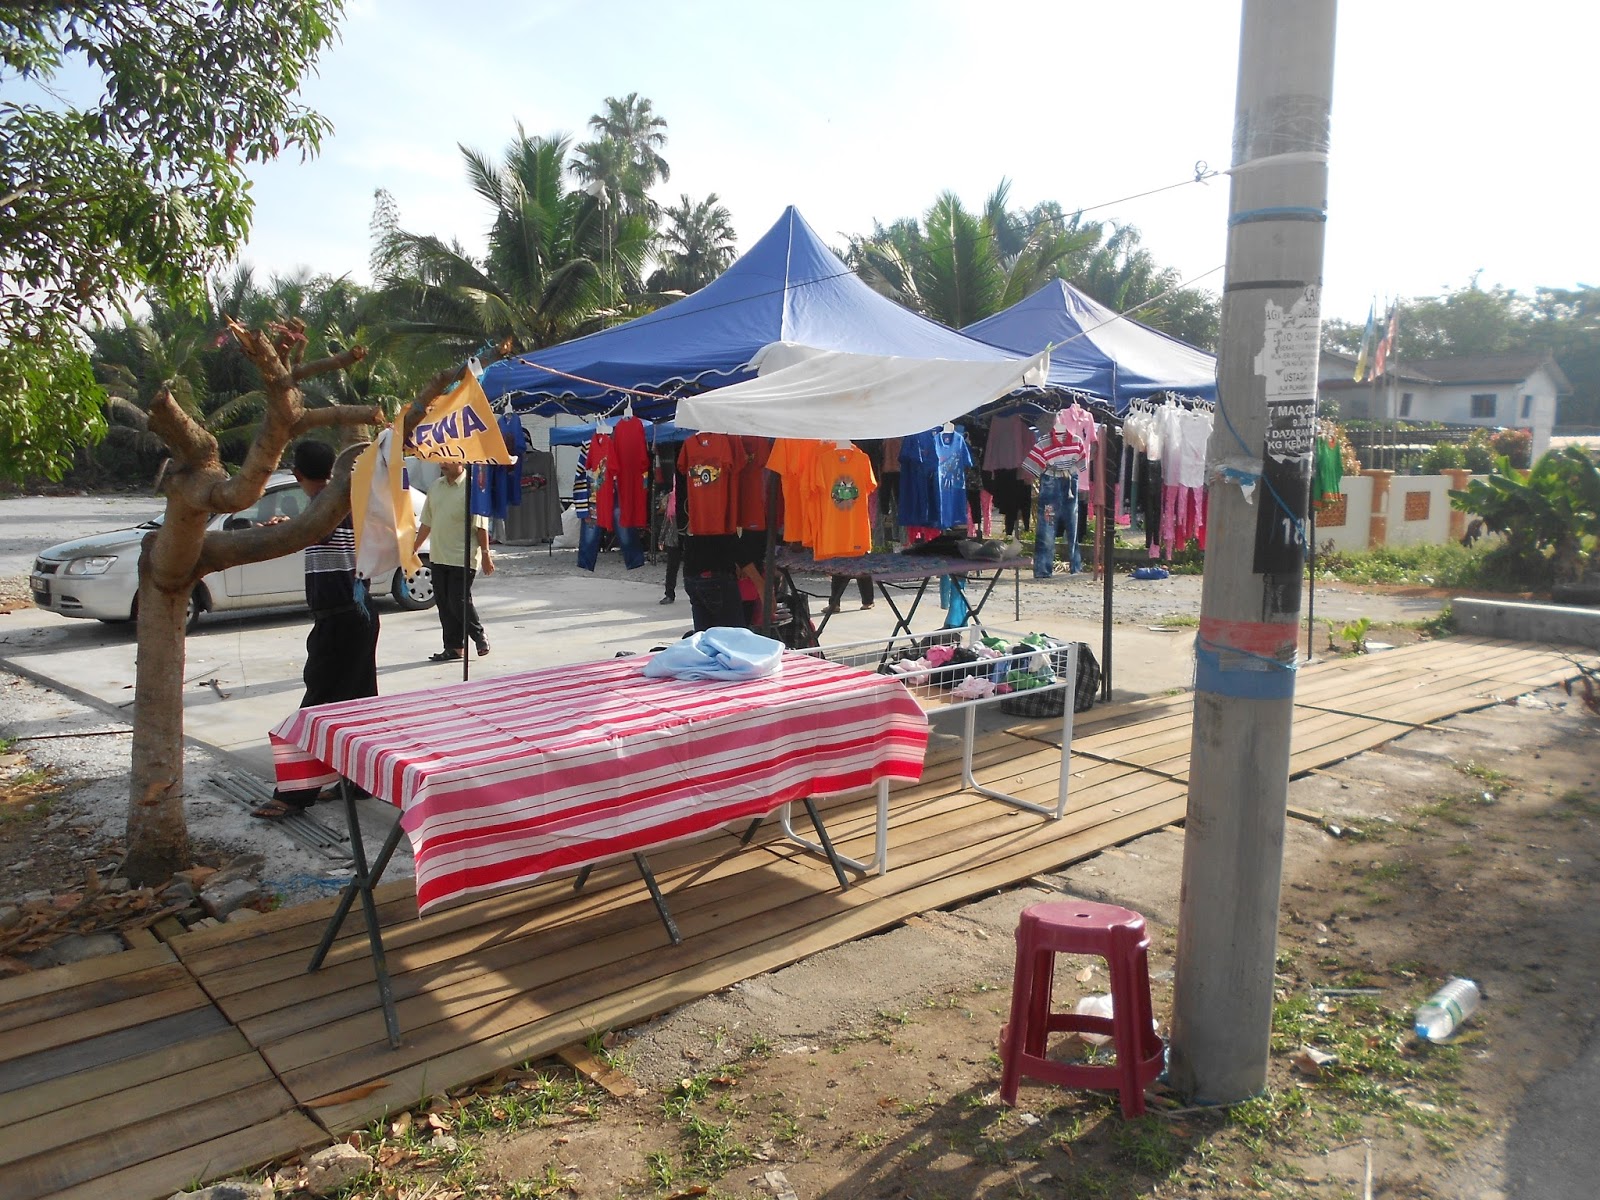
[123,553,190,885]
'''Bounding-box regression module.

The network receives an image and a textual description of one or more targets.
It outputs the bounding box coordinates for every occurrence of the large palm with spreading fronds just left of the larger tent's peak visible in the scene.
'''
[378,125,653,371]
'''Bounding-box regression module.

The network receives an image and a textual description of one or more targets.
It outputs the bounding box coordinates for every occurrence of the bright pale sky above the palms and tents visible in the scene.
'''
[50,0,1600,320]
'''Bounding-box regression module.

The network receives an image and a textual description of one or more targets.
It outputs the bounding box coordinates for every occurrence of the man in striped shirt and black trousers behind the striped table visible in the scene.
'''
[251,440,378,821]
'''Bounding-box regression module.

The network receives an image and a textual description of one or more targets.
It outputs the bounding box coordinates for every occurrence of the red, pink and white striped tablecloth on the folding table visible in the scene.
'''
[270,653,928,912]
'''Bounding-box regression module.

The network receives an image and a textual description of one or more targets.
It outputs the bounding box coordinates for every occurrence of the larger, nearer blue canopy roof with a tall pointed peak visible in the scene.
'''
[483,206,1027,418]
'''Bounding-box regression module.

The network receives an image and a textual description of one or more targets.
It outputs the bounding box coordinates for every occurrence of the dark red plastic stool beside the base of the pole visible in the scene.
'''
[1000,901,1165,1117]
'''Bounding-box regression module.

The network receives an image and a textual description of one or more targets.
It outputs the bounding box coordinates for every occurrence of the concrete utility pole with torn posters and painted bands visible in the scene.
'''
[1170,0,1334,1104]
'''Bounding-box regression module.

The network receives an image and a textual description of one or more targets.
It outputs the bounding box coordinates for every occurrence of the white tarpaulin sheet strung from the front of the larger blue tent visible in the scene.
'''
[677,342,1050,442]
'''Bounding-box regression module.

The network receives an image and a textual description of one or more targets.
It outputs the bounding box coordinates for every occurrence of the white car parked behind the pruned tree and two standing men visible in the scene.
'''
[29,472,434,629]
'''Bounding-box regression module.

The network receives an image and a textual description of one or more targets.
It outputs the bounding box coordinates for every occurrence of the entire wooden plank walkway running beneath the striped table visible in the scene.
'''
[0,638,1581,1200]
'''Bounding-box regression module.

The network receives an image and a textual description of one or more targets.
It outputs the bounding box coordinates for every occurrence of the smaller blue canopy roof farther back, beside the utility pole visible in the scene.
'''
[962,278,1216,411]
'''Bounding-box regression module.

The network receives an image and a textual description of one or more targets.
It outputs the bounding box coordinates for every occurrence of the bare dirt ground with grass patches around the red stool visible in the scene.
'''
[152,678,1600,1200]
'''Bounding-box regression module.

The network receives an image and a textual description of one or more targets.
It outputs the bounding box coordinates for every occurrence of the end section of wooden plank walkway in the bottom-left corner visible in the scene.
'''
[0,946,326,1200]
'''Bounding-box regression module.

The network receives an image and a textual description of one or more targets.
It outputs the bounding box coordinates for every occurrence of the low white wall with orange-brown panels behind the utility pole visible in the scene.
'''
[1317,470,1482,550]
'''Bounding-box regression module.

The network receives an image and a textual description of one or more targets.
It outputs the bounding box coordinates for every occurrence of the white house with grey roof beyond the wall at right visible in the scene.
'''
[1317,350,1573,459]
